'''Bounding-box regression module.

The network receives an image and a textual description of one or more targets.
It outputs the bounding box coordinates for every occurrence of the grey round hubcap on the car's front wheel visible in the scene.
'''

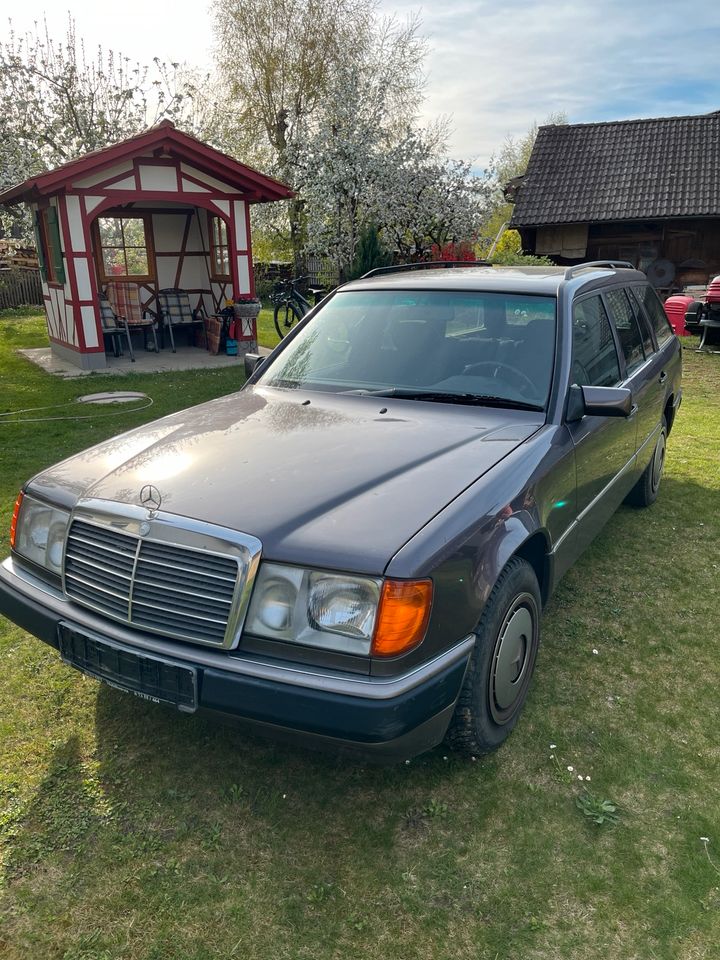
[490,594,537,723]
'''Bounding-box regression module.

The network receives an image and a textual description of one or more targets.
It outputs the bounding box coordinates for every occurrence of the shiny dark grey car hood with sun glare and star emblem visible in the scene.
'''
[31,387,544,574]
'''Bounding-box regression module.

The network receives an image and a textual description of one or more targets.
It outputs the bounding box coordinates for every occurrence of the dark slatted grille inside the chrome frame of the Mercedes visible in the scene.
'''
[65,520,246,646]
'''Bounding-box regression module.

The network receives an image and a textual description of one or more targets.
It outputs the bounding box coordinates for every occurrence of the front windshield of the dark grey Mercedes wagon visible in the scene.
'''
[259,290,556,408]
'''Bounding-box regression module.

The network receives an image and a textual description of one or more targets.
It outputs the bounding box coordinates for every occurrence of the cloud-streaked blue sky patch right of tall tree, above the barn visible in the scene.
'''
[382,0,720,165]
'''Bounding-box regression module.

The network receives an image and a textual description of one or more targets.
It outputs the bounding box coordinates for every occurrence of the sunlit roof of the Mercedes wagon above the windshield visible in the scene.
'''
[340,264,647,296]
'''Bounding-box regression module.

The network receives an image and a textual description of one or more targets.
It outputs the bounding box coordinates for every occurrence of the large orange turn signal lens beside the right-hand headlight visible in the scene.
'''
[371,580,432,657]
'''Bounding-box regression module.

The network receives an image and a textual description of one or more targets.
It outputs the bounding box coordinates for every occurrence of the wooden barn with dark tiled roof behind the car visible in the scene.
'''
[508,112,720,293]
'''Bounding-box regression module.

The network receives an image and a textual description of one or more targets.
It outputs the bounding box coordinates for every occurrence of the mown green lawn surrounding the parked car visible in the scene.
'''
[0,317,720,960]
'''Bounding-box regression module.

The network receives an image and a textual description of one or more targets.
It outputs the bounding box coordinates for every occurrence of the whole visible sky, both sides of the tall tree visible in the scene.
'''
[5,0,720,167]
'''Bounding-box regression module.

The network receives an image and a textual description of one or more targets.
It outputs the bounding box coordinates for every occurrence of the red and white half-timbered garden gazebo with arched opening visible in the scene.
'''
[0,121,292,369]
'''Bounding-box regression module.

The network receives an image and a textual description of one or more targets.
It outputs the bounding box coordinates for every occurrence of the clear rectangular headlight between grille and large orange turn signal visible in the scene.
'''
[245,563,382,656]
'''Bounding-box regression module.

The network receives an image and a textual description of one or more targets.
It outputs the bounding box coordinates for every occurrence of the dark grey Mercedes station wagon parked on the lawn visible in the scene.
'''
[0,262,681,758]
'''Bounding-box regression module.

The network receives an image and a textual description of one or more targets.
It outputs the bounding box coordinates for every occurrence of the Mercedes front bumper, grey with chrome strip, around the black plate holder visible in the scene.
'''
[0,559,474,759]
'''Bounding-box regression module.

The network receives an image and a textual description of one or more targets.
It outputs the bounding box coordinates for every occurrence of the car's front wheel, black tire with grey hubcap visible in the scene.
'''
[446,557,542,756]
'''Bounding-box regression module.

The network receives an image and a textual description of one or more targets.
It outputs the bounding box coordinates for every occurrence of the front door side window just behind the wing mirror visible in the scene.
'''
[572,297,620,387]
